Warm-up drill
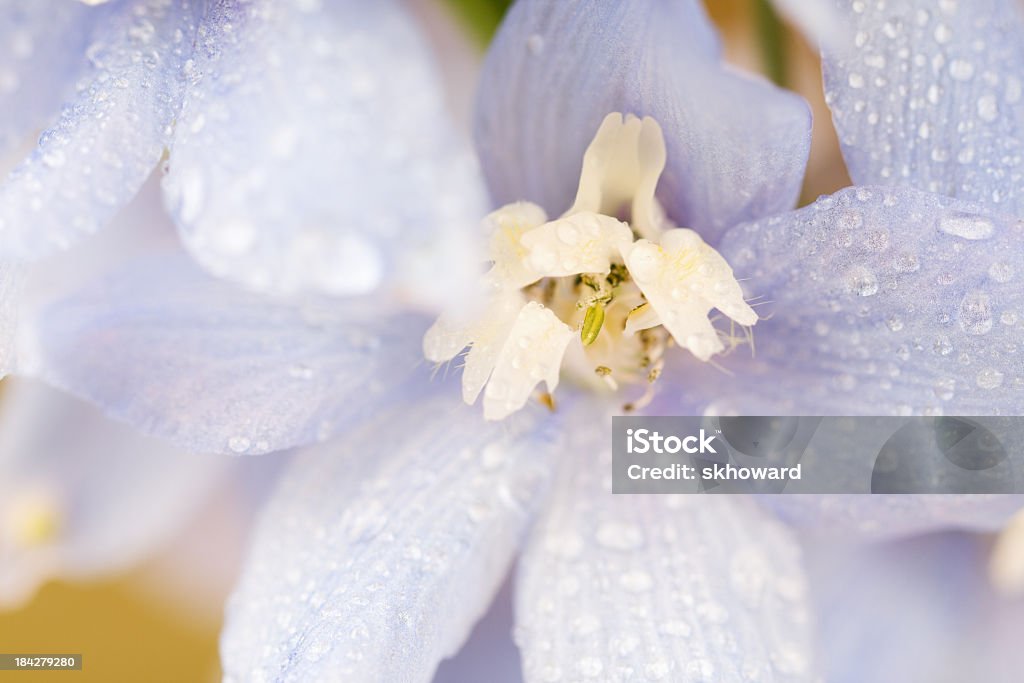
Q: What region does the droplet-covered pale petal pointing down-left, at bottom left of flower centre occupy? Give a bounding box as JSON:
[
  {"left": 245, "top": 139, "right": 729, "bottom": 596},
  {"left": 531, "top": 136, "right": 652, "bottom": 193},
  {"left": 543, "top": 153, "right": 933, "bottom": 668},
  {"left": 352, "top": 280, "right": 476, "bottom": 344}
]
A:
[{"left": 221, "top": 387, "right": 555, "bottom": 681}]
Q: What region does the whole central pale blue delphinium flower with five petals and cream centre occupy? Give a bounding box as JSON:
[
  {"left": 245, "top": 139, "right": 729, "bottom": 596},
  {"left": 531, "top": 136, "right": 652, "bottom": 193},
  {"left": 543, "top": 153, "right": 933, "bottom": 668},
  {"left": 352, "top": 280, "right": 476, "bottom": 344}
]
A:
[{"left": 6, "top": 2, "right": 1020, "bottom": 680}]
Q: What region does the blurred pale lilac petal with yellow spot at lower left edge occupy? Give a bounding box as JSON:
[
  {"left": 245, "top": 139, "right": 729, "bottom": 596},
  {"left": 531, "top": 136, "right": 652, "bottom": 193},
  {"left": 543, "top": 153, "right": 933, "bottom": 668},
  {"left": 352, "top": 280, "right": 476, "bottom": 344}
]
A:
[{"left": 0, "top": 380, "right": 227, "bottom": 606}]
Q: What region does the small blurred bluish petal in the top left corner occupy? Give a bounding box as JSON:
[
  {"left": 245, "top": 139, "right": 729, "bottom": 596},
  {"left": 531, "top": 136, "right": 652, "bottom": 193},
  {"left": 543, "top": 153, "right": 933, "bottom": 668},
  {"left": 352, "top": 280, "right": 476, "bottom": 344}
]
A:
[{"left": 0, "top": 0, "right": 93, "bottom": 160}]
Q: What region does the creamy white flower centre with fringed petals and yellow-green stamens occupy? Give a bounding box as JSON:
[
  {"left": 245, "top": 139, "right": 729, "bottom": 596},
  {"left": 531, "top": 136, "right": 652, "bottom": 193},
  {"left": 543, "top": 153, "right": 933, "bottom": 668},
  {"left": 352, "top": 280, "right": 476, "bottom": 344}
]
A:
[{"left": 423, "top": 114, "right": 758, "bottom": 420}]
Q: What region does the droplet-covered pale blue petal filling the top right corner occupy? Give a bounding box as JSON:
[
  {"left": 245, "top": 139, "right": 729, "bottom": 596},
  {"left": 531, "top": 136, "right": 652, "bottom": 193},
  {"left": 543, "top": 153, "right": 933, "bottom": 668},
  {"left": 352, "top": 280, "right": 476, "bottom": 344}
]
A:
[{"left": 824, "top": 0, "right": 1024, "bottom": 216}]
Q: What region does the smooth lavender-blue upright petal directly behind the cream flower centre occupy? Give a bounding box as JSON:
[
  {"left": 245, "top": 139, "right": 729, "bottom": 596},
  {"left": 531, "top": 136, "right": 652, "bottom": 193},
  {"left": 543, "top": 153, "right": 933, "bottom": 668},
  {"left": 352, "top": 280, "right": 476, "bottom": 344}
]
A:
[{"left": 476, "top": 0, "right": 811, "bottom": 243}]
